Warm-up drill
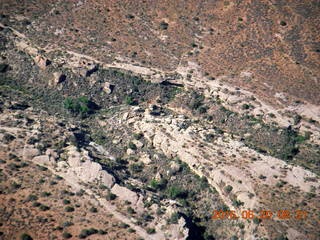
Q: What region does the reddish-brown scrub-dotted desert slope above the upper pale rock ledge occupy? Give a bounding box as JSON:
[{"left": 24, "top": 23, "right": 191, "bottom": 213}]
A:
[{"left": 0, "top": 0, "right": 320, "bottom": 104}]
